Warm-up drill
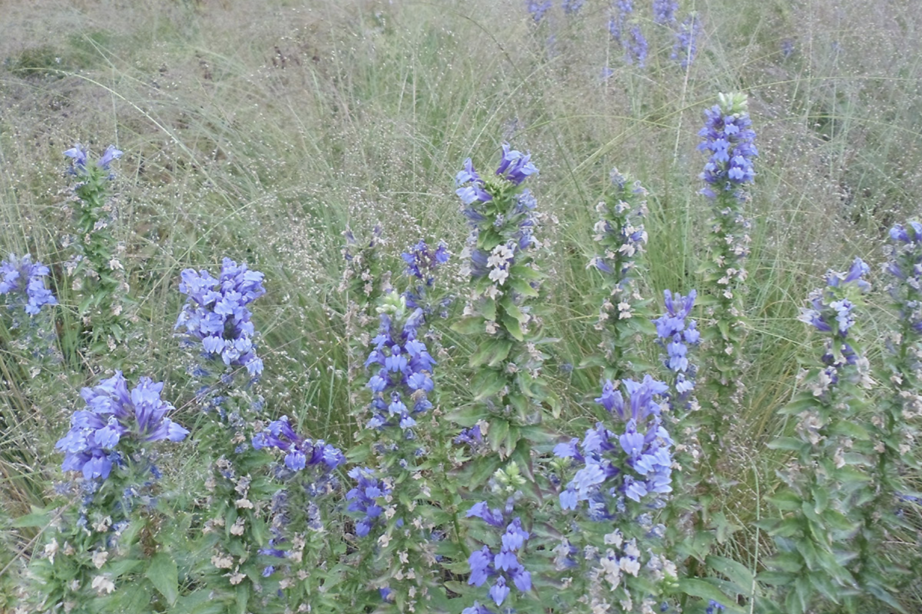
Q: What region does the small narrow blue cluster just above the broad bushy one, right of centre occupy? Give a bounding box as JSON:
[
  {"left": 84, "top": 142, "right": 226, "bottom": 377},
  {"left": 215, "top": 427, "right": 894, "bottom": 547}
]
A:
[{"left": 653, "top": 290, "right": 701, "bottom": 409}]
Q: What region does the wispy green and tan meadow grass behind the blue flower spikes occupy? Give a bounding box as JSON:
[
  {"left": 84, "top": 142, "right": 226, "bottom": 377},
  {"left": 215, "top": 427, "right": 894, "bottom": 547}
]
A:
[{"left": 0, "top": 0, "right": 922, "bottom": 610}]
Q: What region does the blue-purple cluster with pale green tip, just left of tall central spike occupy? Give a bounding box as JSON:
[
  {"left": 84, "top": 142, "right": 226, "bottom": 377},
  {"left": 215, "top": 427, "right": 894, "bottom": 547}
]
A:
[{"left": 365, "top": 309, "right": 435, "bottom": 439}]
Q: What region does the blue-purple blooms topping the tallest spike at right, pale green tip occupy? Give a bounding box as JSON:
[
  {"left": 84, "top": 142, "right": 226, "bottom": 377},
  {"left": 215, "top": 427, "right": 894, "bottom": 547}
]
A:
[{"left": 698, "top": 100, "right": 759, "bottom": 200}]
